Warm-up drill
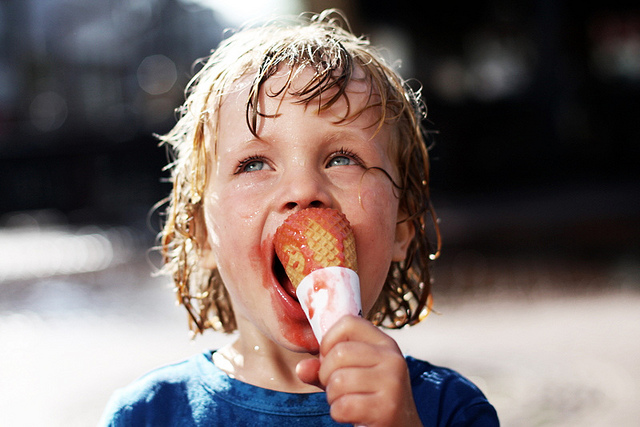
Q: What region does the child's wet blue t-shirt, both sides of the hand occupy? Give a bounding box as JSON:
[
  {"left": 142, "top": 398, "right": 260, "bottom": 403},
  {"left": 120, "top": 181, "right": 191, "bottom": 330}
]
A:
[{"left": 99, "top": 351, "right": 499, "bottom": 427}]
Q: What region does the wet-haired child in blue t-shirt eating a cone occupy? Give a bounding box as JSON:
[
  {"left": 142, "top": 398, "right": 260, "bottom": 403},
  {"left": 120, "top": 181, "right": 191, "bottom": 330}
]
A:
[{"left": 102, "top": 11, "right": 498, "bottom": 426}]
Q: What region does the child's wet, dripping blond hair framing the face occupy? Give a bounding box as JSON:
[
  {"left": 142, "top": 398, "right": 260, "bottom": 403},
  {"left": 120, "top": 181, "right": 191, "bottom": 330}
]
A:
[{"left": 159, "top": 10, "right": 440, "bottom": 333}]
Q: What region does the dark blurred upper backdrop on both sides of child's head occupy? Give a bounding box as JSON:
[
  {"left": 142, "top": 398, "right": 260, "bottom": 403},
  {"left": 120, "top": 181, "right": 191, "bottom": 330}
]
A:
[{"left": 0, "top": 0, "right": 640, "bottom": 270}]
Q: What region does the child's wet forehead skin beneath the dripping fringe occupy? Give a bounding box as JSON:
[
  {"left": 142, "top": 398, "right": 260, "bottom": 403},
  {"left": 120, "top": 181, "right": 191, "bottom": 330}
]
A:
[{"left": 207, "top": 68, "right": 396, "bottom": 166}]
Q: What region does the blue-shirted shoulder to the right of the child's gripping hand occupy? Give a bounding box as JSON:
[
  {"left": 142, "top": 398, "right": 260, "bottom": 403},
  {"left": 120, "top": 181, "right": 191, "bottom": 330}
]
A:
[{"left": 405, "top": 356, "right": 499, "bottom": 427}]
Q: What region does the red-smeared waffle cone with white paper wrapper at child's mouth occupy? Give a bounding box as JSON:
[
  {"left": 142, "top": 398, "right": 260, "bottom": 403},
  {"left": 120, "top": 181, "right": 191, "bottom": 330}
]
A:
[{"left": 274, "top": 208, "right": 362, "bottom": 342}]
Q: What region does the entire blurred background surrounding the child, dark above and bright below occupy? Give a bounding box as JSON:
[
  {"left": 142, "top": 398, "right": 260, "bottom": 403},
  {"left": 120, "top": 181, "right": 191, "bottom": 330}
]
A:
[{"left": 0, "top": 0, "right": 640, "bottom": 426}]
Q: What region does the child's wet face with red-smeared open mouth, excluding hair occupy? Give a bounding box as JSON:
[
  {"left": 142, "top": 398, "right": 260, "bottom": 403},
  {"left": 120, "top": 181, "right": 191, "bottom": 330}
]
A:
[{"left": 203, "top": 67, "right": 413, "bottom": 352}]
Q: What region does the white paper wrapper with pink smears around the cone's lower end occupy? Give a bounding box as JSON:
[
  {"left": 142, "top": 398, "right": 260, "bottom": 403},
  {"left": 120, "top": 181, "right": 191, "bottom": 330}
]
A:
[{"left": 296, "top": 267, "right": 362, "bottom": 342}]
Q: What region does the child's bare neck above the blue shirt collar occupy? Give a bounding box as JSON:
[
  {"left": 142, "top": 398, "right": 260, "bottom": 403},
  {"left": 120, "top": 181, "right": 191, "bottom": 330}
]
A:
[{"left": 213, "top": 337, "right": 320, "bottom": 393}]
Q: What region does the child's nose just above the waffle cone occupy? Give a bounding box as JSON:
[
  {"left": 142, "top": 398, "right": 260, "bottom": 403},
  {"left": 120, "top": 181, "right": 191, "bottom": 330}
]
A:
[{"left": 281, "top": 169, "right": 332, "bottom": 211}]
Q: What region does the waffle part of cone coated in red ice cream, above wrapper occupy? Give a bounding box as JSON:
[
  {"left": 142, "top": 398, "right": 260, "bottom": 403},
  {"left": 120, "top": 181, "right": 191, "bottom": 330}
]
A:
[{"left": 274, "top": 208, "right": 358, "bottom": 288}]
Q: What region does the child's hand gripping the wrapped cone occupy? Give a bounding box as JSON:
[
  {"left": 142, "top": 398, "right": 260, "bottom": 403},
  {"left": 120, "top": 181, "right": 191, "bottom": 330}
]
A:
[{"left": 297, "top": 316, "right": 422, "bottom": 427}]
